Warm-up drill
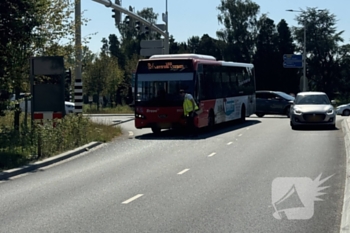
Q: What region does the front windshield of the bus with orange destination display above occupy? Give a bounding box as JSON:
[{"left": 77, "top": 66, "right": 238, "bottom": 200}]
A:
[{"left": 135, "top": 60, "right": 194, "bottom": 106}]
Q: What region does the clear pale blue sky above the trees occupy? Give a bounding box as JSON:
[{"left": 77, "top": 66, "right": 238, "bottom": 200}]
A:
[{"left": 81, "top": 0, "right": 350, "bottom": 53}]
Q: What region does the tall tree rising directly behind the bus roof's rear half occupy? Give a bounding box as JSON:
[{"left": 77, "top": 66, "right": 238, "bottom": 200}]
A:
[{"left": 216, "top": 0, "right": 259, "bottom": 62}]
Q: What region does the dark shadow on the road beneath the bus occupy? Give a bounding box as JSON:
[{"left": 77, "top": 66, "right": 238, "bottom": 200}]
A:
[{"left": 135, "top": 120, "right": 260, "bottom": 140}]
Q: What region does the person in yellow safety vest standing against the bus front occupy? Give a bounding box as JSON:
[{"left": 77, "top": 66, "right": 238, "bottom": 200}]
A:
[{"left": 180, "top": 89, "right": 199, "bottom": 136}]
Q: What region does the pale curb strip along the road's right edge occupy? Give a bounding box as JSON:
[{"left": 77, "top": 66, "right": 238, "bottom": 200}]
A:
[{"left": 340, "top": 118, "right": 350, "bottom": 233}]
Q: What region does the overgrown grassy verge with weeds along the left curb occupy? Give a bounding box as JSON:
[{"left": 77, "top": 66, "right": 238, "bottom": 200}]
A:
[{"left": 0, "top": 112, "right": 122, "bottom": 171}]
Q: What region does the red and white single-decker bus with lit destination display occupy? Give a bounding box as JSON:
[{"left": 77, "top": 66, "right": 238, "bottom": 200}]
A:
[{"left": 135, "top": 54, "right": 255, "bottom": 133}]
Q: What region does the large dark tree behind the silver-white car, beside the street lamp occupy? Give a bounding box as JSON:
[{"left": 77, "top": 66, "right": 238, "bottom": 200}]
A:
[{"left": 294, "top": 8, "right": 344, "bottom": 98}]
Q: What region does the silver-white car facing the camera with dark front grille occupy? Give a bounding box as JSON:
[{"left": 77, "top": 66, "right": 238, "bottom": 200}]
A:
[{"left": 290, "top": 92, "right": 336, "bottom": 129}]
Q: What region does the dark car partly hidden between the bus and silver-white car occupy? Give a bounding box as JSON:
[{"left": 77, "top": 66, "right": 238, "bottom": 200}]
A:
[{"left": 255, "top": 91, "right": 294, "bottom": 117}]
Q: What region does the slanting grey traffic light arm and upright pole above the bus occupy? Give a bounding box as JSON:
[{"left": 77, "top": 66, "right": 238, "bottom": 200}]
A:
[{"left": 92, "top": 0, "right": 169, "bottom": 54}]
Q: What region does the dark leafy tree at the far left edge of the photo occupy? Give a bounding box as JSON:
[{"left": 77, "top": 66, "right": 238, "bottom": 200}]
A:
[{"left": 0, "top": 0, "right": 44, "bottom": 124}]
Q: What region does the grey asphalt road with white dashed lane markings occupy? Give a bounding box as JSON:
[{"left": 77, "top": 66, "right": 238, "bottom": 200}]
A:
[{"left": 0, "top": 117, "right": 345, "bottom": 233}]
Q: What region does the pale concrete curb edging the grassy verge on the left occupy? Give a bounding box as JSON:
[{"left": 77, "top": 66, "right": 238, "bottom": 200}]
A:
[{"left": 0, "top": 142, "right": 102, "bottom": 180}]
